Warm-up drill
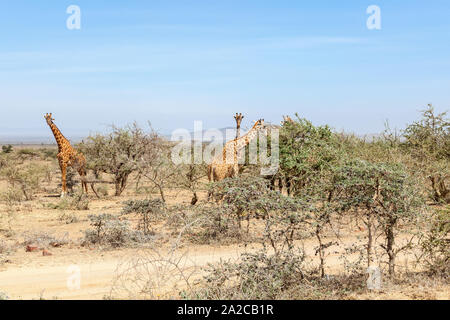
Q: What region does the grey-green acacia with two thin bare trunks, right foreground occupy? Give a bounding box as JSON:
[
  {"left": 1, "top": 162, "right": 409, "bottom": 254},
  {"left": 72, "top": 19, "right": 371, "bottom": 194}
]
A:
[{"left": 333, "top": 160, "right": 423, "bottom": 275}]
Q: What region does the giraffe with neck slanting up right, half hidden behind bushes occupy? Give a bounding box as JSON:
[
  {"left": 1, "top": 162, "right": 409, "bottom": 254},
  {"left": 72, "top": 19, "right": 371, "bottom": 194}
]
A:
[{"left": 208, "top": 119, "right": 265, "bottom": 182}]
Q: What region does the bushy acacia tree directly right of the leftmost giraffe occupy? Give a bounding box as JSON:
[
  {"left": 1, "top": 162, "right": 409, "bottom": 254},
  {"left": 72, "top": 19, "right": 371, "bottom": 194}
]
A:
[{"left": 79, "top": 123, "right": 160, "bottom": 196}]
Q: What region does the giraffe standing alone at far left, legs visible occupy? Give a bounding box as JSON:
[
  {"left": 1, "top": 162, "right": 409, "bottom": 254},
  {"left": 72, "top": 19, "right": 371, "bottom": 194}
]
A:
[{"left": 44, "top": 113, "right": 88, "bottom": 197}]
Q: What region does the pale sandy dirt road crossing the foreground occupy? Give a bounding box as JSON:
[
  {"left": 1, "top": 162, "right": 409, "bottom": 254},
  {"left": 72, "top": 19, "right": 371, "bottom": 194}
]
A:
[{"left": 0, "top": 247, "right": 248, "bottom": 299}]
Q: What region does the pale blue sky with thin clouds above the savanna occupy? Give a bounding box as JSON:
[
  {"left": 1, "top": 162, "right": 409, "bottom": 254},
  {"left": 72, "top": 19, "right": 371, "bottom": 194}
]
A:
[{"left": 0, "top": 0, "right": 450, "bottom": 136}]
